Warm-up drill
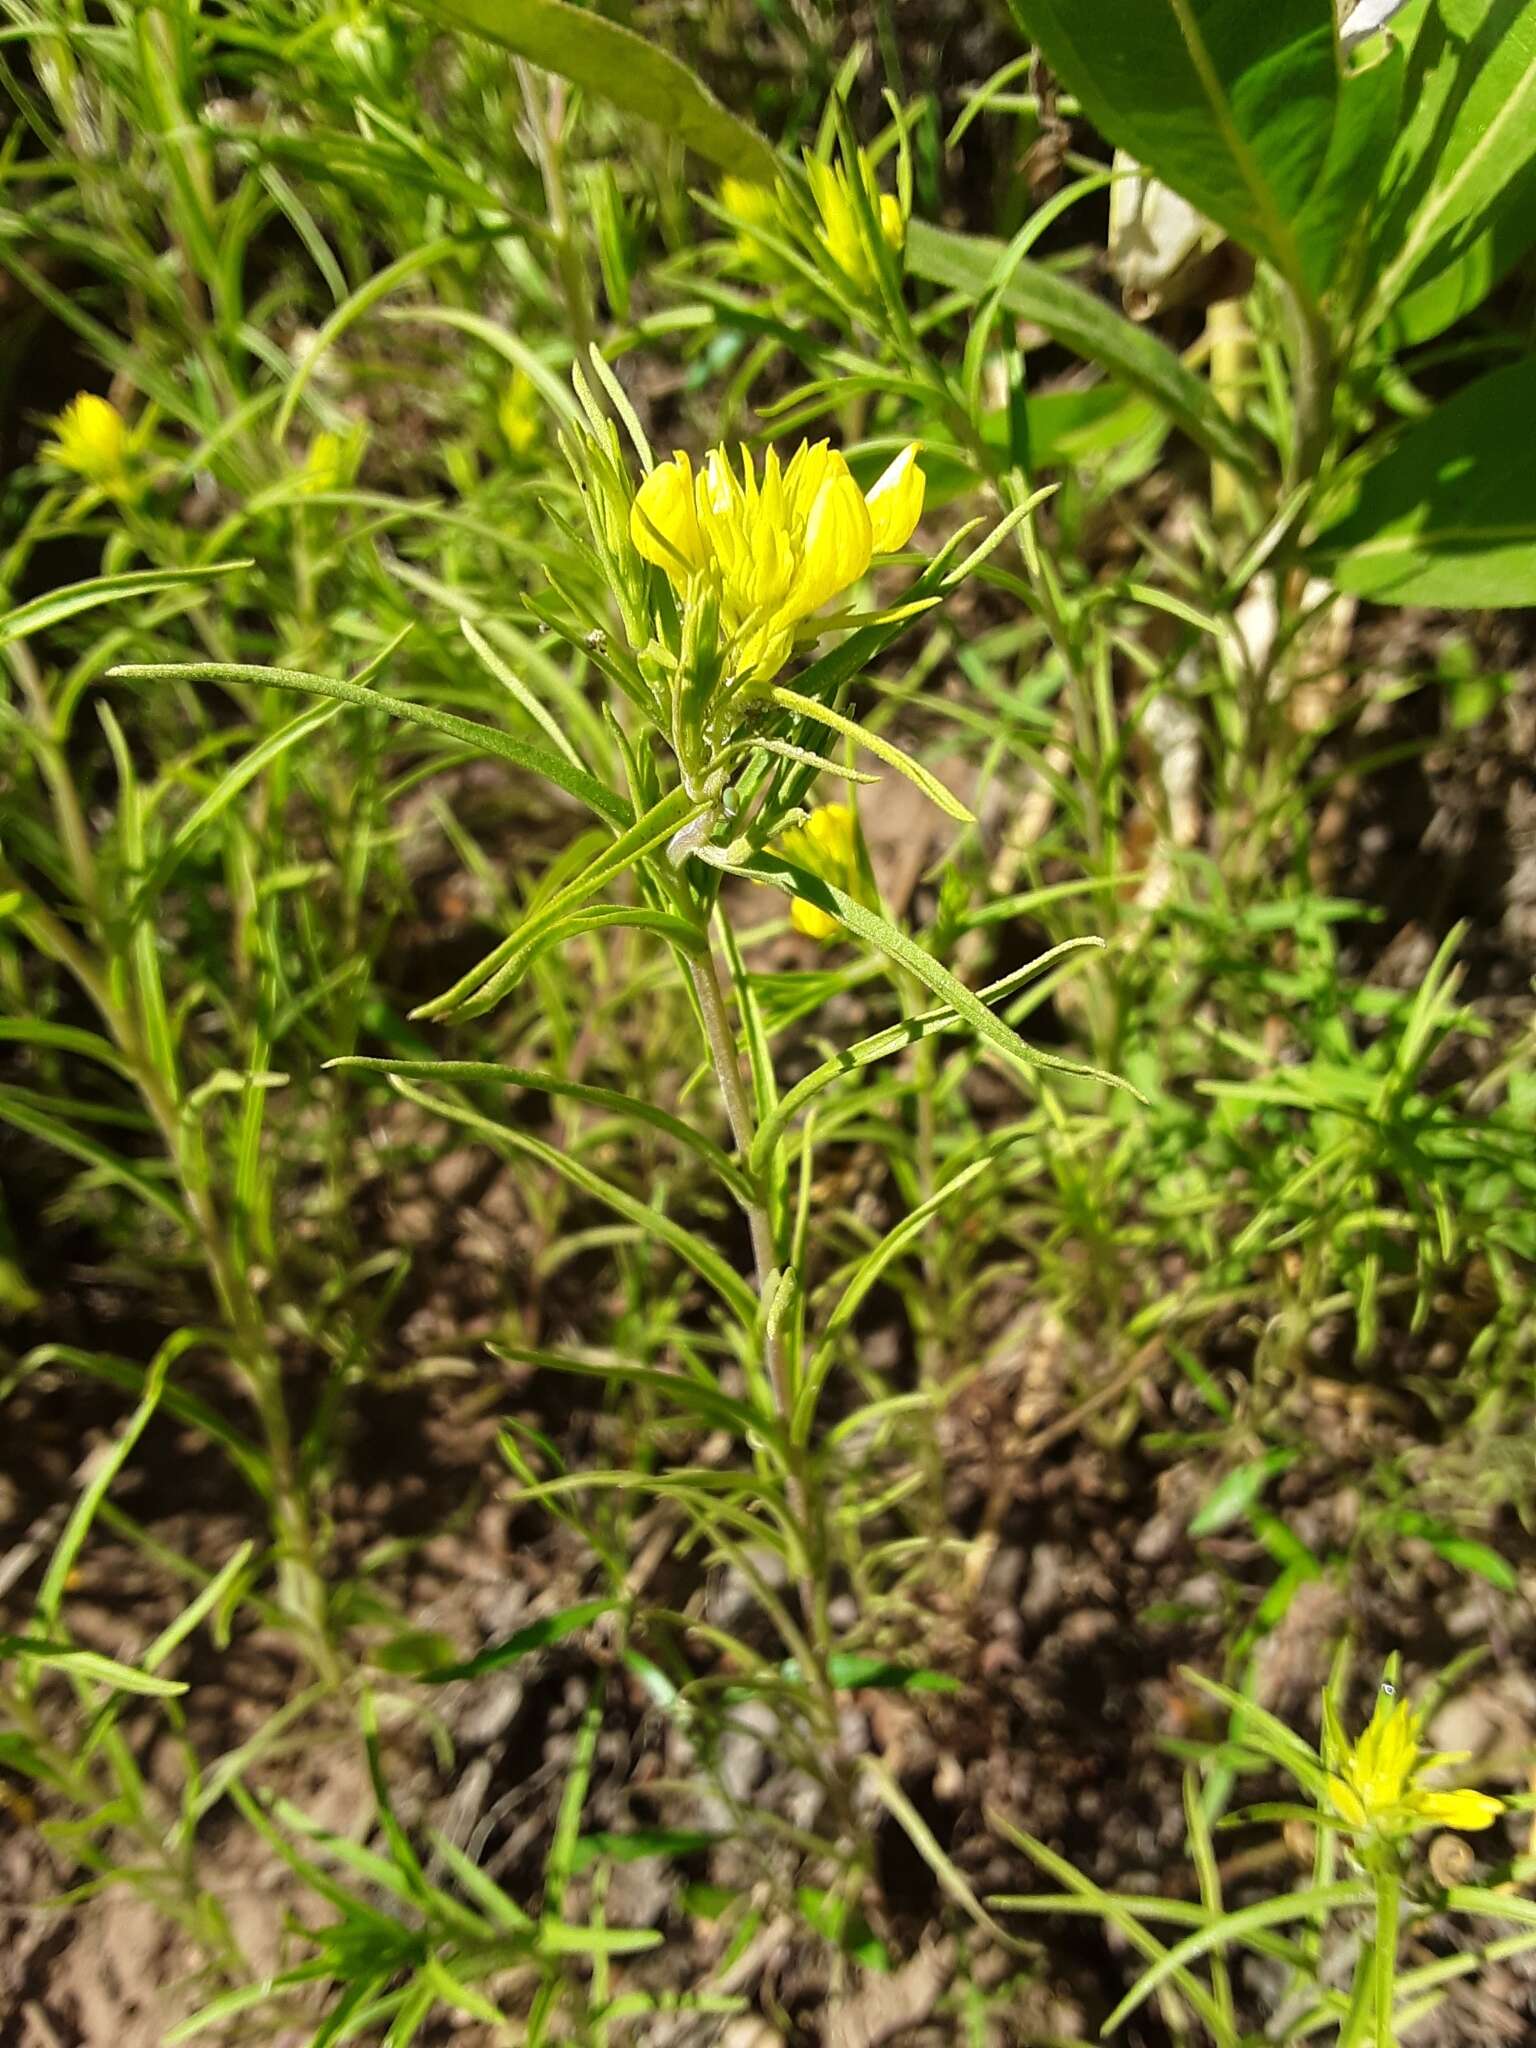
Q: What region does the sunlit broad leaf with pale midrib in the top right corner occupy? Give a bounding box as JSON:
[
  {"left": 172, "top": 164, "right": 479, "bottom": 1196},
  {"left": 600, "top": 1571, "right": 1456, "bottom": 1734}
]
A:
[{"left": 1372, "top": 0, "right": 1536, "bottom": 317}]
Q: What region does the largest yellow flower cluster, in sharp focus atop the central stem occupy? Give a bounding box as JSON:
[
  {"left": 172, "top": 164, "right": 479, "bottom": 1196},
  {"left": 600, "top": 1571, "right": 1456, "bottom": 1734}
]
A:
[{"left": 629, "top": 440, "right": 924, "bottom": 682}]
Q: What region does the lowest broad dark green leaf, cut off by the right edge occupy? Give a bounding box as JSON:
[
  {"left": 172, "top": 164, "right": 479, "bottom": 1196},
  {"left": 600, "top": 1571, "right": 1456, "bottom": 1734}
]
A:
[{"left": 1313, "top": 358, "right": 1536, "bottom": 606}]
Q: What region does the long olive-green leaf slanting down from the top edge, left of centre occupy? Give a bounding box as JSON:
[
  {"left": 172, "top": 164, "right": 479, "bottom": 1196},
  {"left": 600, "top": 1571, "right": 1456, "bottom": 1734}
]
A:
[{"left": 408, "top": 0, "right": 778, "bottom": 182}]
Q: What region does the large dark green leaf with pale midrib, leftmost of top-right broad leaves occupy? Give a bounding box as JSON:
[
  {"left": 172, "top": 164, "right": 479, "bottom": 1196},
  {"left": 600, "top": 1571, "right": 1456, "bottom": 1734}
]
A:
[{"left": 1012, "top": 0, "right": 1364, "bottom": 283}]
